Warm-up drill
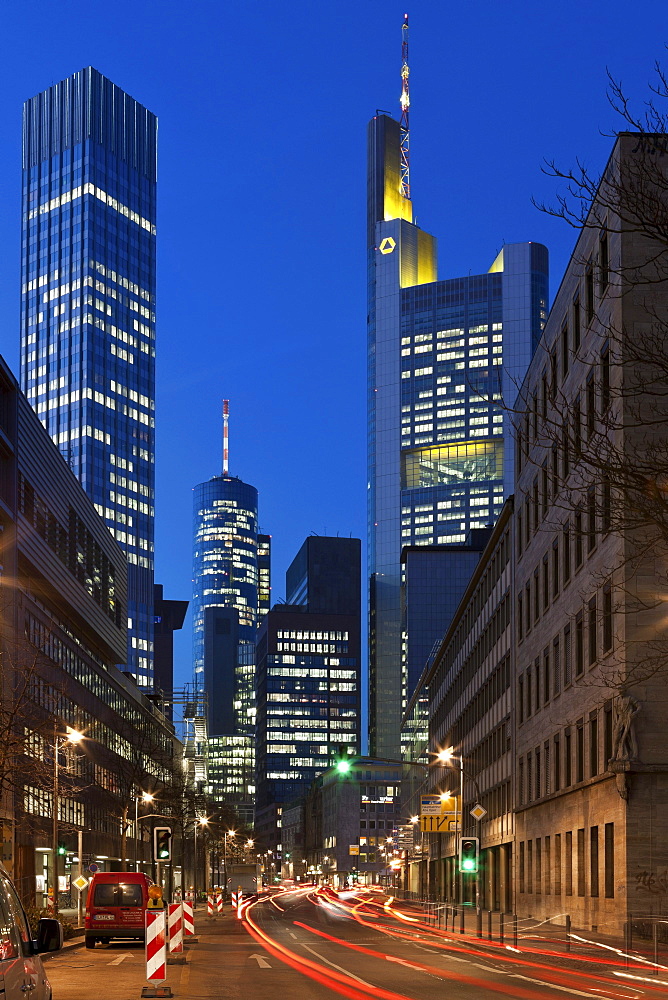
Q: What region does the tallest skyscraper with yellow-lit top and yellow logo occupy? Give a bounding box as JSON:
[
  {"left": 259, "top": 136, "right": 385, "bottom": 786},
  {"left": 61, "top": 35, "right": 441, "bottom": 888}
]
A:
[{"left": 367, "top": 45, "right": 548, "bottom": 758}]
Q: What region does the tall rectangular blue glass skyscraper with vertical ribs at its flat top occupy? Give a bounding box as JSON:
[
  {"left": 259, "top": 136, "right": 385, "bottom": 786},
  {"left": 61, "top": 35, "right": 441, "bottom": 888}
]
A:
[{"left": 21, "top": 67, "right": 157, "bottom": 687}]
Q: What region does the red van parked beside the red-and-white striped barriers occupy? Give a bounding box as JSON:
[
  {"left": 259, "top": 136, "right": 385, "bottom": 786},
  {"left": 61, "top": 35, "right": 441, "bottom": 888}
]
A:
[{"left": 85, "top": 872, "right": 153, "bottom": 948}]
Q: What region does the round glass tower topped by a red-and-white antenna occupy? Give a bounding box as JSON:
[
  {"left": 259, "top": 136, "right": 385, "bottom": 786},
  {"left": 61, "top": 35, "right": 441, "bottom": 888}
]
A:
[{"left": 193, "top": 475, "right": 258, "bottom": 736}]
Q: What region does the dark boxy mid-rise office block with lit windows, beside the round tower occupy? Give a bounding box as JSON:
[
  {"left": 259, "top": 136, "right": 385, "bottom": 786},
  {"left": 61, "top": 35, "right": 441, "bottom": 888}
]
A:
[{"left": 256, "top": 537, "right": 361, "bottom": 846}]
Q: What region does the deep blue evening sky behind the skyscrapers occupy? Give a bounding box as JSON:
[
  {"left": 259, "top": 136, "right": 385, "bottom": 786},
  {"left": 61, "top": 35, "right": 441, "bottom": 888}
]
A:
[{"left": 0, "top": 0, "right": 668, "bottom": 704}]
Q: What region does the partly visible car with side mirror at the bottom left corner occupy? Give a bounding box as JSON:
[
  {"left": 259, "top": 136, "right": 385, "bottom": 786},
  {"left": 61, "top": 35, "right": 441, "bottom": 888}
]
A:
[{"left": 0, "top": 868, "right": 63, "bottom": 1000}]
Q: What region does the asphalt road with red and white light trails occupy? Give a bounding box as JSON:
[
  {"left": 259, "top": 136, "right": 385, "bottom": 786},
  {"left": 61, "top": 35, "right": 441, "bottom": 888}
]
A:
[{"left": 47, "top": 890, "right": 668, "bottom": 1000}]
